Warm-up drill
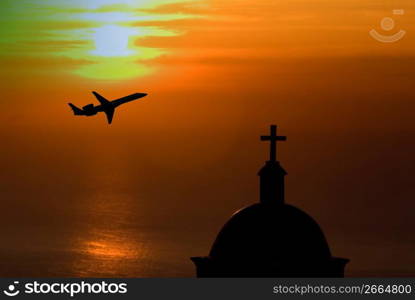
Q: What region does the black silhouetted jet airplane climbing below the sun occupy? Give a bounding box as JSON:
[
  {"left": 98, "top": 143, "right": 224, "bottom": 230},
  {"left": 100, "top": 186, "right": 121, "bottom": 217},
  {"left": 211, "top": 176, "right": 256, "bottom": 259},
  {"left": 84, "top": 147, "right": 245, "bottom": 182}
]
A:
[{"left": 68, "top": 92, "right": 147, "bottom": 124}]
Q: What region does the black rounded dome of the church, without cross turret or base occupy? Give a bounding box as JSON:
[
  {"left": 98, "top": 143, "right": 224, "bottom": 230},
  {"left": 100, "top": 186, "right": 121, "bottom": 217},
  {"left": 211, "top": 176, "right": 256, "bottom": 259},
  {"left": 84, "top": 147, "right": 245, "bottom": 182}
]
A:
[{"left": 209, "top": 203, "right": 331, "bottom": 264}]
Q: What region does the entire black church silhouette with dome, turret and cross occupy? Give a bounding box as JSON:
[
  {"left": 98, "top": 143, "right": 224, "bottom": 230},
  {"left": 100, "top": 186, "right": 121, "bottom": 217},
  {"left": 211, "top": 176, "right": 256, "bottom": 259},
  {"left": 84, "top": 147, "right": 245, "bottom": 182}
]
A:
[{"left": 191, "top": 125, "right": 349, "bottom": 277}]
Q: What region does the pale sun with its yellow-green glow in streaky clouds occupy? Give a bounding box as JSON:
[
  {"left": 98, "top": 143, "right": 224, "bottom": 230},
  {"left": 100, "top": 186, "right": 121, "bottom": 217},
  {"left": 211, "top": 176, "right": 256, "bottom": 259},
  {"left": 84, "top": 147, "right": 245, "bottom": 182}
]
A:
[{"left": 0, "top": 0, "right": 202, "bottom": 80}]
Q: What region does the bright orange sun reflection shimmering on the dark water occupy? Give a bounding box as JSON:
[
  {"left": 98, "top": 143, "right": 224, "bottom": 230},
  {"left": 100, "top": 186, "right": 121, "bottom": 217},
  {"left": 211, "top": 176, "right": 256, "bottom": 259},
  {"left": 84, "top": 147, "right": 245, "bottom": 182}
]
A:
[{"left": 72, "top": 196, "right": 149, "bottom": 277}]
